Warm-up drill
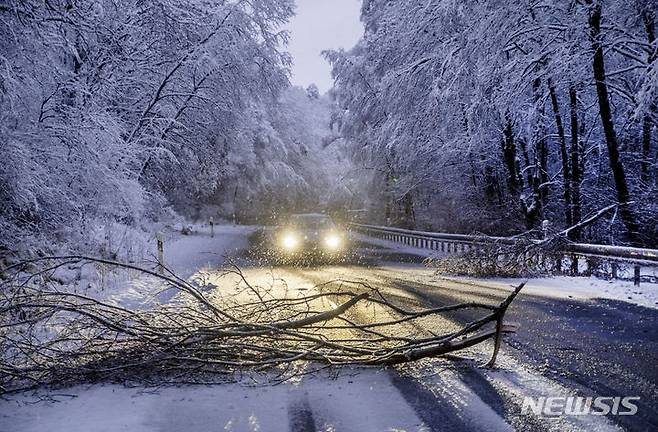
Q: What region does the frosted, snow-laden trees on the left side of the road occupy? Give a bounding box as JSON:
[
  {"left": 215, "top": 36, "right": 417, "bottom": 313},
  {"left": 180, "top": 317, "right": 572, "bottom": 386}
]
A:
[{"left": 0, "top": 0, "right": 356, "bottom": 256}]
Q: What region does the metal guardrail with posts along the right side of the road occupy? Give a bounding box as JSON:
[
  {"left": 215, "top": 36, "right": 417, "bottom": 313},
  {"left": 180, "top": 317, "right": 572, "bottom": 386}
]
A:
[{"left": 349, "top": 223, "right": 658, "bottom": 285}]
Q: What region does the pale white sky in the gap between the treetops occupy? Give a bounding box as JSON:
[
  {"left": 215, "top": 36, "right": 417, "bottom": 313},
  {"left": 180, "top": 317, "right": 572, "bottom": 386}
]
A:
[{"left": 288, "top": 0, "right": 363, "bottom": 93}]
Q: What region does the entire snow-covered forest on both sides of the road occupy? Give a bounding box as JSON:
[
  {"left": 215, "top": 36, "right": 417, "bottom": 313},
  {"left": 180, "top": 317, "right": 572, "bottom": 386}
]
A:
[{"left": 0, "top": 0, "right": 658, "bottom": 256}]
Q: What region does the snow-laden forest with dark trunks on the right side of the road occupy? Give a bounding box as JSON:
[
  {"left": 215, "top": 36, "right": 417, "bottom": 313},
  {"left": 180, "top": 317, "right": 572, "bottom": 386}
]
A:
[{"left": 326, "top": 0, "right": 658, "bottom": 246}]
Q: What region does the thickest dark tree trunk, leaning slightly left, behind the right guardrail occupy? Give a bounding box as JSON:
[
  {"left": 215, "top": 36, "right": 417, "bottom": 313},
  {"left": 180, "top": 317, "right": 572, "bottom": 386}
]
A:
[{"left": 589, "top": 0, "right": 641, "bottom": 245}]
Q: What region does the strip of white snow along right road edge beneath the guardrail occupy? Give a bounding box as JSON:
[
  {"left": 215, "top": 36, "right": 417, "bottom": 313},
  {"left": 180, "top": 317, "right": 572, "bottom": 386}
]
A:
[{"left": 351, "top": 233, "right": 658, "bottom": 309}]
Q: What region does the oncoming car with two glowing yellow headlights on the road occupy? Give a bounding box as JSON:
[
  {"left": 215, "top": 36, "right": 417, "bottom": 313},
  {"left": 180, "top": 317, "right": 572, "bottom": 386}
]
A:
[{"left": 273, "top": 213, "right": 348, "bottom": 261}]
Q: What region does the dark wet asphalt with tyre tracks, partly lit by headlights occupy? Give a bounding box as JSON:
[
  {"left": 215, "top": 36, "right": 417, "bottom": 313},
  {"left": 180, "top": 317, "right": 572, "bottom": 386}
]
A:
[{"left": 224, "top": 233, "right": 658, "bottom": 431}]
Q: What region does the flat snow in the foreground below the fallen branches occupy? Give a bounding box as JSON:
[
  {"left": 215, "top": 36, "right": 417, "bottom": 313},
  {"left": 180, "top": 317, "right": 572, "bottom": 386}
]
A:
[{"left": 0, "top": 370, "right": 429, "bottom": 432}]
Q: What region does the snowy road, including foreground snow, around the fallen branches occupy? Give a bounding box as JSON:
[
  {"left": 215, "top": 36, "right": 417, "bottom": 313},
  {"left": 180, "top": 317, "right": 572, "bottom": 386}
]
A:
[{"left": 0, "top": 230, "right": 658, "bottom": 432}]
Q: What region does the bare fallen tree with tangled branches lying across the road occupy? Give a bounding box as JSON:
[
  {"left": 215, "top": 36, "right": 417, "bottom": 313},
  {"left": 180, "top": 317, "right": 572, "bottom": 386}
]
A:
[{"left": 0, "top": 256, "right": 523, "bottom": 392}]
